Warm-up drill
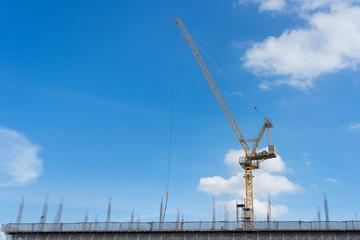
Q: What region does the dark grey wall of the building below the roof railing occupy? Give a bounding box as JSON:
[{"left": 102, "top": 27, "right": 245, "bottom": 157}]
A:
[{"left": 7, "top": 231, "right": 360, "bottom": 240}]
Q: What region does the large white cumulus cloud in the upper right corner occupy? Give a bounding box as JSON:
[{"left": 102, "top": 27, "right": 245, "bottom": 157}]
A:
[{"left": 242, "top": 0, "right": 360, "bottom": 90}]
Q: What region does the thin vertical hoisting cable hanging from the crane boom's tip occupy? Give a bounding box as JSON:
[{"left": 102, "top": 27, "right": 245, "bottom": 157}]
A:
[{"left": 162, "top": 23, "right": 178, "bottom": 222}]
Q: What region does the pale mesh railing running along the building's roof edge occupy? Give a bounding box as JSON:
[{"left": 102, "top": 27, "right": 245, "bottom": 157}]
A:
[{"left": 1, "top": 221, "right": 360, "bottom": 234}]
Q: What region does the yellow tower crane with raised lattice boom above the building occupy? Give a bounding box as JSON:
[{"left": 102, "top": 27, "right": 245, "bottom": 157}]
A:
[{"left": 173, "top": 18, "right": 276, "bottom": 222}]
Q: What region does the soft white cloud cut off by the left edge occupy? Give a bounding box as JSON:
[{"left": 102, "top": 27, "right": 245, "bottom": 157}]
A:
[{"left": 0, "top": 127, "right": 42, "bottom": 187}]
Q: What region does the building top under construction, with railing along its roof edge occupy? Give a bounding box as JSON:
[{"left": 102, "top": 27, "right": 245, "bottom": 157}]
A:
[{"left": 2, "top": 221, "right": 360, "bottom": 240}]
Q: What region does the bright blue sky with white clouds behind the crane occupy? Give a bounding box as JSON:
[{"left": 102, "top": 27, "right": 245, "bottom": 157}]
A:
[{"left": 0, "top": 0, "right": 360, "bottom": 229}]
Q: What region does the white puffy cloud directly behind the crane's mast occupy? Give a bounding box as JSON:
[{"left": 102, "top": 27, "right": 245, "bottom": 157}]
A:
[{"left": 198, "top": 149, "right": 300, "bottom": 218}]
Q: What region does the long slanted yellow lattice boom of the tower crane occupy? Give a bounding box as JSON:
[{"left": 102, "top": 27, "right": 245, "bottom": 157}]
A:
[{"left": 174, "top": 18, "right": 250, "bottom": 156}]
